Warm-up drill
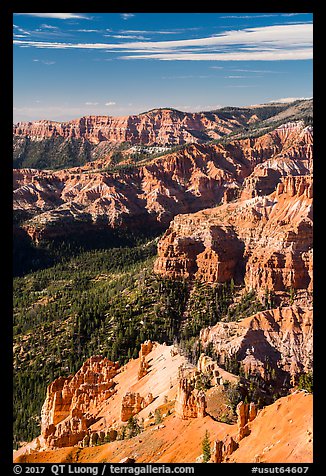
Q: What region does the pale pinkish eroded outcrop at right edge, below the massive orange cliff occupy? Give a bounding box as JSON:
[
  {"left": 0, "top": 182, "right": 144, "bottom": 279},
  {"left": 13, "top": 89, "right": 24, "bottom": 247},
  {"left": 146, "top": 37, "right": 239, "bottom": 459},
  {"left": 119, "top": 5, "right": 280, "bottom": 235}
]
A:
[{"left": 200, "top": 306, "right": 313, "bottom": 380}]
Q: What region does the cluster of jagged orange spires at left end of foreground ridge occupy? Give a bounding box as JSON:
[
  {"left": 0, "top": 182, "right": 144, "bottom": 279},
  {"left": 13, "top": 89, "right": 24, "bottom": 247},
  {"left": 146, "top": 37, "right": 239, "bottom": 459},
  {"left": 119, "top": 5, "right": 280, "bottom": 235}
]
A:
[{"left": 41, "top": 356, "right": 119, "bottom": 447}]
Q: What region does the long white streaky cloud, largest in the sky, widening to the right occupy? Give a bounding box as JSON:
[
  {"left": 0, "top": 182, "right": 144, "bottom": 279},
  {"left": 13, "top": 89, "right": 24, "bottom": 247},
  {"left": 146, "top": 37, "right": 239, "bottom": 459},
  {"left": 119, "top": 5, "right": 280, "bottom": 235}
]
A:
[{"left": 14, "top": 23, "right": 313, "bottom": 61}]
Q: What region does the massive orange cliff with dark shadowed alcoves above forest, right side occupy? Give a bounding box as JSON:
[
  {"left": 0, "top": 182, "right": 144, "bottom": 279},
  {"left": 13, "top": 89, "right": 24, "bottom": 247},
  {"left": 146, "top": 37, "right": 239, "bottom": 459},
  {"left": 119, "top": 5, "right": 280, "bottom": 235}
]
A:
[{"left": 154, "top": 175, "right": 313, "bottom": 294}]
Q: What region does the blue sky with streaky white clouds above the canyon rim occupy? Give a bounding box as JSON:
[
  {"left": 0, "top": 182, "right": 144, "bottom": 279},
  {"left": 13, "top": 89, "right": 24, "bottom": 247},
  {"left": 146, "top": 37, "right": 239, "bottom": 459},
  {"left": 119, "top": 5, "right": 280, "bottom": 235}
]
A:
[{"left": 13, "top": 12, "right": 313, "bottom": 122}]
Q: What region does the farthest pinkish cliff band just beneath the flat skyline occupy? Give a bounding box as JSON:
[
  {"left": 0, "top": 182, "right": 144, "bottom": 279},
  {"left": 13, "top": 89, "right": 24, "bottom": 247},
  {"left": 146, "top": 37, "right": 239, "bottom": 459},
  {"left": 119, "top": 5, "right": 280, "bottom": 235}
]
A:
[{"left": 13, "top": 109, "right": 247, "bottom": 145}]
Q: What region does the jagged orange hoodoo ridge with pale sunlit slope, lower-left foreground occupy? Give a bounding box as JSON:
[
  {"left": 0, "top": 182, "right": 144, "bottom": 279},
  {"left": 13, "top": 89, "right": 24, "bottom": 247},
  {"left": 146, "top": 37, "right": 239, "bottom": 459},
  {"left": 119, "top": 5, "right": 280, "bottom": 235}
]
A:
[{"left": 18, "top": 341, "right": 191, "bottom": 454}]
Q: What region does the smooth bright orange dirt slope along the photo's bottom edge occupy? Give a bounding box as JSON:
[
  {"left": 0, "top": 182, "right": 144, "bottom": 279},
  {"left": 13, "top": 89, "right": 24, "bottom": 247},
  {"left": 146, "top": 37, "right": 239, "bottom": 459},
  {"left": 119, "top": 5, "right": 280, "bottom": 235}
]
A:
[{"left": 14, "top": 392, "right": 313, "bottom": 462}]
